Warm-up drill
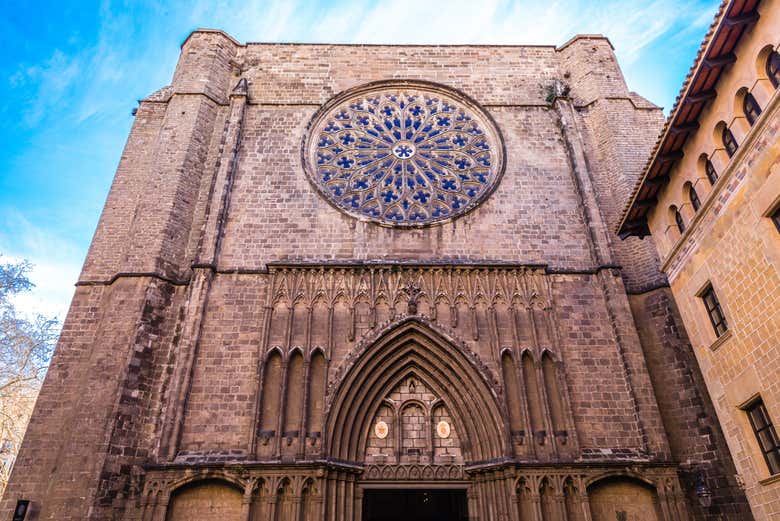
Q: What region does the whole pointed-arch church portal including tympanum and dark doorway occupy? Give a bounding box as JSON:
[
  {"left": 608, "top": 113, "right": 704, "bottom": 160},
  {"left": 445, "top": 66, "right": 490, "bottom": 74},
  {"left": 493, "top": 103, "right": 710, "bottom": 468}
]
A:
[{"left": 325, "top": 319, "right": 510, "bottom": 521}]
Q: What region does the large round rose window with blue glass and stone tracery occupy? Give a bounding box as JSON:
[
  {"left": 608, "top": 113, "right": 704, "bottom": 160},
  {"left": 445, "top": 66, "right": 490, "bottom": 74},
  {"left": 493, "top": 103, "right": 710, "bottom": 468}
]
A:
[{"left": 305, "top": 83, "right": 503, "bottom": 226}]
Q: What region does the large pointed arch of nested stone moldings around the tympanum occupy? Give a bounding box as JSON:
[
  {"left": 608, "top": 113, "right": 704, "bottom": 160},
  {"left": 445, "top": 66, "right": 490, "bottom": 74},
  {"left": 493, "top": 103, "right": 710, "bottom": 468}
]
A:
[{"left": 325, "top": 319, "right": 508, "bottom": 462}]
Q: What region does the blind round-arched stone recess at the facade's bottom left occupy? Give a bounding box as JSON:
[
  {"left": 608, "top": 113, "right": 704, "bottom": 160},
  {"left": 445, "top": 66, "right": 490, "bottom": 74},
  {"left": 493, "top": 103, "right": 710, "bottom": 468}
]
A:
[{"left": 165, "top": 479, "right": 243, "bottom": 521}]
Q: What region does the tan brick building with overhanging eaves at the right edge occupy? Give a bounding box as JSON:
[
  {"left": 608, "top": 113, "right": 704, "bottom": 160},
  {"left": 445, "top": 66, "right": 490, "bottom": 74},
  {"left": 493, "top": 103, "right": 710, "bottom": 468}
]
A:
[{"left": 620, "top": 0, "right": 780, "bottom": 520}]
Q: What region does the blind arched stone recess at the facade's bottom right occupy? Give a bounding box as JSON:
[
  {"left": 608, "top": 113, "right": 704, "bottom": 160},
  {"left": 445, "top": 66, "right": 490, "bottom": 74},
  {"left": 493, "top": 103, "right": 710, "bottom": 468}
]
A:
[{"left": 588, "top": 476, "right": 664, "bottom": 521}]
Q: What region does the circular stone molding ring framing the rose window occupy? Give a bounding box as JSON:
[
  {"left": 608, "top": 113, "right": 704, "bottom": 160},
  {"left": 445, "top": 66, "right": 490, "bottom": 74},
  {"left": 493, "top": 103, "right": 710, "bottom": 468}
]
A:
[{"left": 300, "top": 79, "right": 506, "bottom": 229}]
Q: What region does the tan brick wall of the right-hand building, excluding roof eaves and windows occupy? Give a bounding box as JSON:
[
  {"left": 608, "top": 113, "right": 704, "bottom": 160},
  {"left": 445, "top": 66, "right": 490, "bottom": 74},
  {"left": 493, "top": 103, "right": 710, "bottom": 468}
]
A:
[{"left": 648, "top": 1, "right": 780, "bottom": 519}]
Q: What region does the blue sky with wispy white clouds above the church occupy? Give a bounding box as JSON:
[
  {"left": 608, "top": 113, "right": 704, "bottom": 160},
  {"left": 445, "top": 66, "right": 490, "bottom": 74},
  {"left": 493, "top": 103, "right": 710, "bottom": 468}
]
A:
[{"left": 0, "top": 0, "right": 719, "bottom": 319}]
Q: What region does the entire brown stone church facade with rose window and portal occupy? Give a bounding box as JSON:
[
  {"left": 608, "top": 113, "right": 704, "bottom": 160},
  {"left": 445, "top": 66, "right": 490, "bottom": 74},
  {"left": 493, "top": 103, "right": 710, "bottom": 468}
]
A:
[{"left": 0, "top": 25, "right": 752, "bottom": 521}]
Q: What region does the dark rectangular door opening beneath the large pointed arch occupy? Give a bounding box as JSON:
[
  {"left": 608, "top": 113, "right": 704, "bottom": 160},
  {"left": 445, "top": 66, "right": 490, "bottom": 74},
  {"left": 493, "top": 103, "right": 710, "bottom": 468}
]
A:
[{"left": 363, "top": 489, "right": 468, "bottom": 521}]
